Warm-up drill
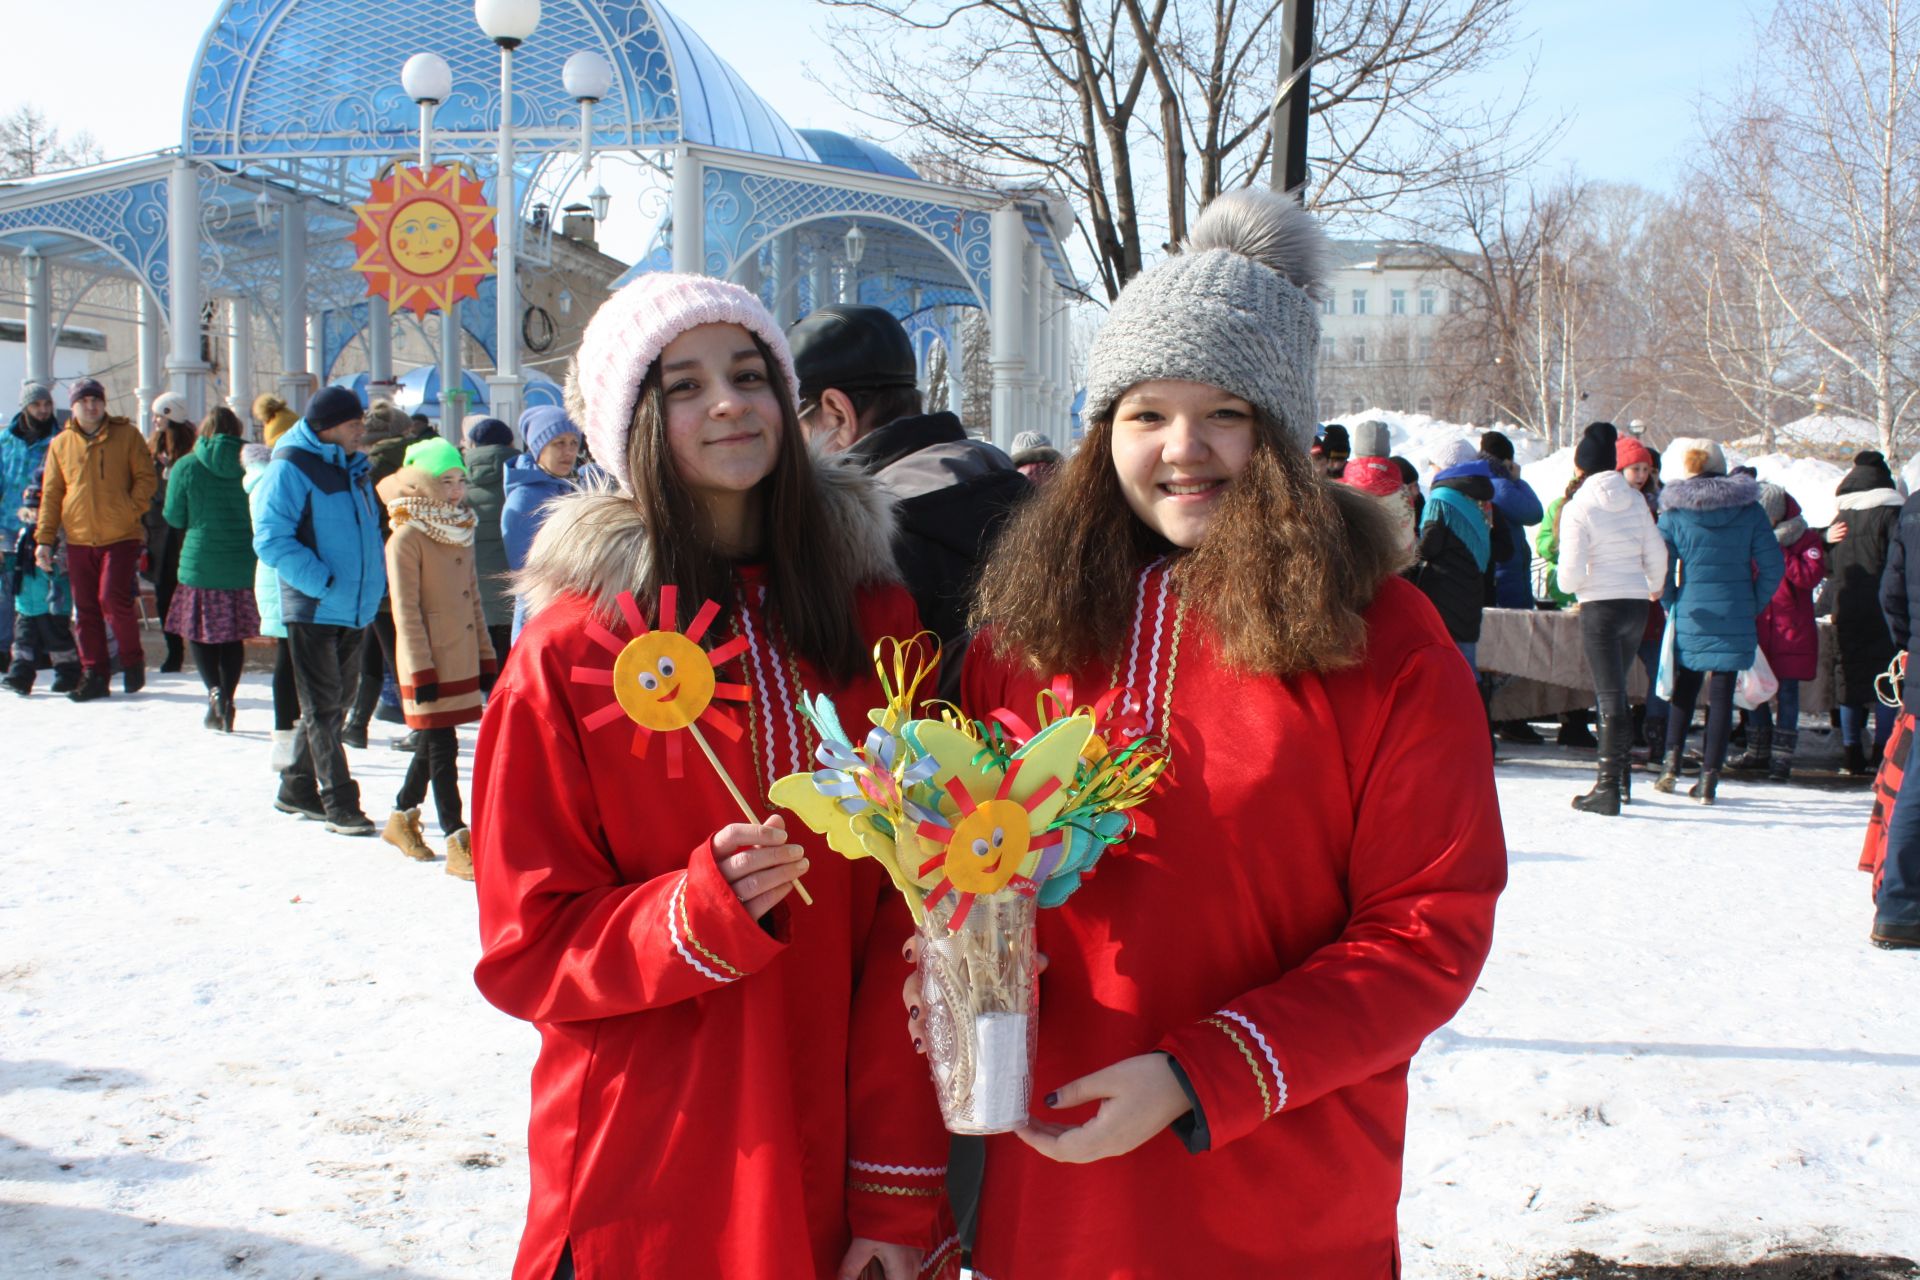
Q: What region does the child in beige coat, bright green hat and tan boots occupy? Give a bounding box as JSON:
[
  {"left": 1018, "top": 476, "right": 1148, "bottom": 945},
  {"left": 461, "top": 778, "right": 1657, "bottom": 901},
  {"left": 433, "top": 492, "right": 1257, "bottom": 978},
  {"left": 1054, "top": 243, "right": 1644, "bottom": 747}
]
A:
[{"left": 378, "top": 436, "right": 495, "bottom": 881}]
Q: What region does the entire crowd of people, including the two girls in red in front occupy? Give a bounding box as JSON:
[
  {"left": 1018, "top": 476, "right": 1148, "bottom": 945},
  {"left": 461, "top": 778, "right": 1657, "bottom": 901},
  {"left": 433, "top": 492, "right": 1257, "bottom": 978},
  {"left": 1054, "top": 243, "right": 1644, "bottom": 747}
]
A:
[{"left": 0, "top": 190, "right": 1920, "bottom": 1280}]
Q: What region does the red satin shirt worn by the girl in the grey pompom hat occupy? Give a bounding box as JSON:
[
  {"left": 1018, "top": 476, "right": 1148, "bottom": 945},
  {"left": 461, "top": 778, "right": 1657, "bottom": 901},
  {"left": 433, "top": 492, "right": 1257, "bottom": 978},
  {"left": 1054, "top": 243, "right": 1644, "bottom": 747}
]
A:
[{"left": 964, "top": 566, "right": 1507, "bottom": 1280}]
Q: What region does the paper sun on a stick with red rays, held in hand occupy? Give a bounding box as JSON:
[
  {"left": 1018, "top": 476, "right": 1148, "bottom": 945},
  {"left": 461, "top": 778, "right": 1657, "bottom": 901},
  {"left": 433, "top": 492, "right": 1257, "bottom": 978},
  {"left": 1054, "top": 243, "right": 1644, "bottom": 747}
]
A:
[{"left": 572, "top": 585, "right": 814, "bottom": 906}]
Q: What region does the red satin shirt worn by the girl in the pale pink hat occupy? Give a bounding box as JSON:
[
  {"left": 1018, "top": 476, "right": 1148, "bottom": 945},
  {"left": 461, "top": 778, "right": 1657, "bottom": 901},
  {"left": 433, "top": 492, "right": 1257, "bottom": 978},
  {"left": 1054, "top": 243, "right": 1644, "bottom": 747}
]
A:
[{"left": 472, "top": 570, "right": 956, "bottom": 1280}]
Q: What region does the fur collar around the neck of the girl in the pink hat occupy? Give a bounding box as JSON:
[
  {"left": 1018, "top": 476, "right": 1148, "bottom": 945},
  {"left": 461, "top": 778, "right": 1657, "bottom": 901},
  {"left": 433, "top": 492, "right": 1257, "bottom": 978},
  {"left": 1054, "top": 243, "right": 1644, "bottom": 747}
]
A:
[{"left": 513, "top": 453, "right": 900, "bottom": 618}]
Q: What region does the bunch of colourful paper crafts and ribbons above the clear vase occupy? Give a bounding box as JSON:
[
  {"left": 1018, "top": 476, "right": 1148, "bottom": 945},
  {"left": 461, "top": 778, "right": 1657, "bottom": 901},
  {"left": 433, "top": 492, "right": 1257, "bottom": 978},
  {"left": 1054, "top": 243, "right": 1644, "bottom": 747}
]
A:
[{"left": 770, "top": 633, "right": 1167, "bottom": 931}]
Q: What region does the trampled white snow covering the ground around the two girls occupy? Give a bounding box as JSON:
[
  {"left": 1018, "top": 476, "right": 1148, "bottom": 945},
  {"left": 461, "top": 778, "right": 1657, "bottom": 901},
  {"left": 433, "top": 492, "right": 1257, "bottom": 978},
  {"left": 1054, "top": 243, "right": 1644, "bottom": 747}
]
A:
[{"left": 0, "top": 676, "right": 1920, "bottom": 1280}]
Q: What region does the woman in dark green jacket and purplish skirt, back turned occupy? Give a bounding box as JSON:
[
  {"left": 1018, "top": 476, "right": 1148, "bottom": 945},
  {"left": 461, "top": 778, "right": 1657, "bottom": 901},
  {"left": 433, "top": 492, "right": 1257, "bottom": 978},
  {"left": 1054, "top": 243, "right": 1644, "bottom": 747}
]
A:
[{"left": 165, "top": 405, "right": 259, "bottom": 733}]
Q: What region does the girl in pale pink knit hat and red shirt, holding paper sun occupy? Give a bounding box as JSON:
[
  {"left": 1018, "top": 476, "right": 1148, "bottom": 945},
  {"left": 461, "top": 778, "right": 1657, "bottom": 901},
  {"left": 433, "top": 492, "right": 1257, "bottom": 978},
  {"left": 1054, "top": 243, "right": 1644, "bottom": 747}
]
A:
[{"left": 472, "top": 274, "right": 954, "bottom": 1280}]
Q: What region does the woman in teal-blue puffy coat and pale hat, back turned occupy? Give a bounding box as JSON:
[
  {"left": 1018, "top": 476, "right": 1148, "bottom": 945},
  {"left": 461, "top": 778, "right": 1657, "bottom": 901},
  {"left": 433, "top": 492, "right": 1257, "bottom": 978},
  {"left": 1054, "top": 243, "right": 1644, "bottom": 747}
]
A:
[{"left": 1653, "top": 439, "right": 1786, "bottom": 804}]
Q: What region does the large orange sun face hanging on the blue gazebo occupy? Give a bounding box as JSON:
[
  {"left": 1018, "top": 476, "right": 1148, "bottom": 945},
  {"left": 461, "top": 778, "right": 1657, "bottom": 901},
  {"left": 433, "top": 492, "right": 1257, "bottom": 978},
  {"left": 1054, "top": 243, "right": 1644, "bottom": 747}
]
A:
[{"left": 349, "top": 165, "right": 497, "bottom": 315}]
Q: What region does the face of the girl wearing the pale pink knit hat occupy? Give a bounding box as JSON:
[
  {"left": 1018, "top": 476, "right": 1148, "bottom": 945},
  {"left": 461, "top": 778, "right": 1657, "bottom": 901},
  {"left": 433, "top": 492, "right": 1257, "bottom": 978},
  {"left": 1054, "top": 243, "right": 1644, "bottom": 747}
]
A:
[{"left": 660, "top": 324, "right": 780, "bottom": 507}]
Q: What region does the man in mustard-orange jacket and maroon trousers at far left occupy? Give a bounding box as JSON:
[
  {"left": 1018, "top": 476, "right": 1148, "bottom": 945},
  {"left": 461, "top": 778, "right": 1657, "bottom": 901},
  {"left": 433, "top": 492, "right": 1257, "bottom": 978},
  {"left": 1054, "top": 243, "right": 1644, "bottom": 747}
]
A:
[{"left": 35, "top": 378, "right": 159, "bottom": 702}]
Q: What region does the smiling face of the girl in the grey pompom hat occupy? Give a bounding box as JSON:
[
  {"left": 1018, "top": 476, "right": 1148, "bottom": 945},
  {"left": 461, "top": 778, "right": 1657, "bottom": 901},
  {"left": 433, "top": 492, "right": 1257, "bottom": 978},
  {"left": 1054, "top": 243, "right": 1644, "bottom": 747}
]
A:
[{"left": 1114, "top": 380, "right": 1254, "bottom": 549}]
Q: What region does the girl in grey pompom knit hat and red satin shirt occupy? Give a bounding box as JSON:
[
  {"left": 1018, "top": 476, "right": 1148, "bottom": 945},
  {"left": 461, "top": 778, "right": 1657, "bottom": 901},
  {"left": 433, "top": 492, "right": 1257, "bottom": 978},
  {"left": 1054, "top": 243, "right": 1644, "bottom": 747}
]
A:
[{"left": 908, "top": 192, "right": 1505, "bottom": 1280}]
